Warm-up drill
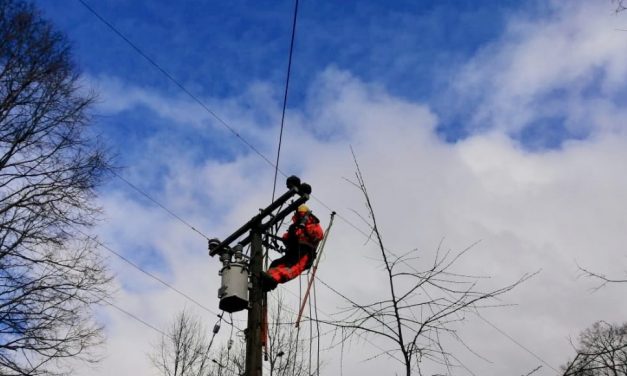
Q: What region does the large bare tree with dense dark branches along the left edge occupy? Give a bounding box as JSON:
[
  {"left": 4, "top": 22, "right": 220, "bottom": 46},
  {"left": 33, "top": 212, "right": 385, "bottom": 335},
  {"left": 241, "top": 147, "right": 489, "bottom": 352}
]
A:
[{"left": 0, "top": 0, "right": 110, "bottom": 375}]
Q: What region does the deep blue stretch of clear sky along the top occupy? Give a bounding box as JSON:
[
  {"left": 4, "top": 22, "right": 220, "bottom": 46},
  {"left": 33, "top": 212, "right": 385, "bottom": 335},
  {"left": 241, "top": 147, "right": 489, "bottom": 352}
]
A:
[{"left": 38, "top": 1, "right": 546, "bottom": 147}]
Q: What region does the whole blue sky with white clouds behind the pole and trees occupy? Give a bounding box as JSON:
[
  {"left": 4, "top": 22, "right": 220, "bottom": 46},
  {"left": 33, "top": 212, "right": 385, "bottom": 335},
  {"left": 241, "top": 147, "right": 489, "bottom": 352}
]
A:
[{"left": 35, "top": 0, "right": 627, "bottom": 376}]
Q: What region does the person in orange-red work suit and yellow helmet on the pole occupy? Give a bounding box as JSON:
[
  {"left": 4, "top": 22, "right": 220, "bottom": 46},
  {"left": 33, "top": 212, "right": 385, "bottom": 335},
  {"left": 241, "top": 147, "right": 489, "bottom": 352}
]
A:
[{"left": 262, "top": 205, "right": 323, "bottom": 291}]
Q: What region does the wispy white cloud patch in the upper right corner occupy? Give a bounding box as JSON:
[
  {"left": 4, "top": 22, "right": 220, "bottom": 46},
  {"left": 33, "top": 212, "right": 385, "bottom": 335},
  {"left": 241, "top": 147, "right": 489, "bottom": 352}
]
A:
[{"left": 453, "top": 1, "right": 627, "bottom": 132}]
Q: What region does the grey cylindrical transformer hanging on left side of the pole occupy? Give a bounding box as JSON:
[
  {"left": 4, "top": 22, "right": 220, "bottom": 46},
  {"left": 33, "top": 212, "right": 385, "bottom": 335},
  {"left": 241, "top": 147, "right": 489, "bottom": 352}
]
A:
[{"left": 218, "top": 245, "right": 248, "bottom": 313}]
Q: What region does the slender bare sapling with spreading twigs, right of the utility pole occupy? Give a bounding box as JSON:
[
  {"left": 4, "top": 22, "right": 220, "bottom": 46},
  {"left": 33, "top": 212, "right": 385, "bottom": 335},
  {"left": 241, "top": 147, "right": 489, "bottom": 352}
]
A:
[{"left": 328, "top": 151, "right": 529, "bottom": 376}]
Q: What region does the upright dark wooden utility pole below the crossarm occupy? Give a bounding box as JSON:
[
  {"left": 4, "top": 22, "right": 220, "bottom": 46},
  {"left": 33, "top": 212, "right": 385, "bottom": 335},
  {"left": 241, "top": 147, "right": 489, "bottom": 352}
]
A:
[{"left": 245, "top": 222, "right": 263, "bottom": 376}]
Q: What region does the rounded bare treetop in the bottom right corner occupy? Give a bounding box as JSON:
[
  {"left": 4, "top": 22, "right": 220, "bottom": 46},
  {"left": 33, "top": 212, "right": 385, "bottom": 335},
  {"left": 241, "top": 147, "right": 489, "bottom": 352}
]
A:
[{"left": 562, "top": 321, "right": 627, "bottom": 376}]
